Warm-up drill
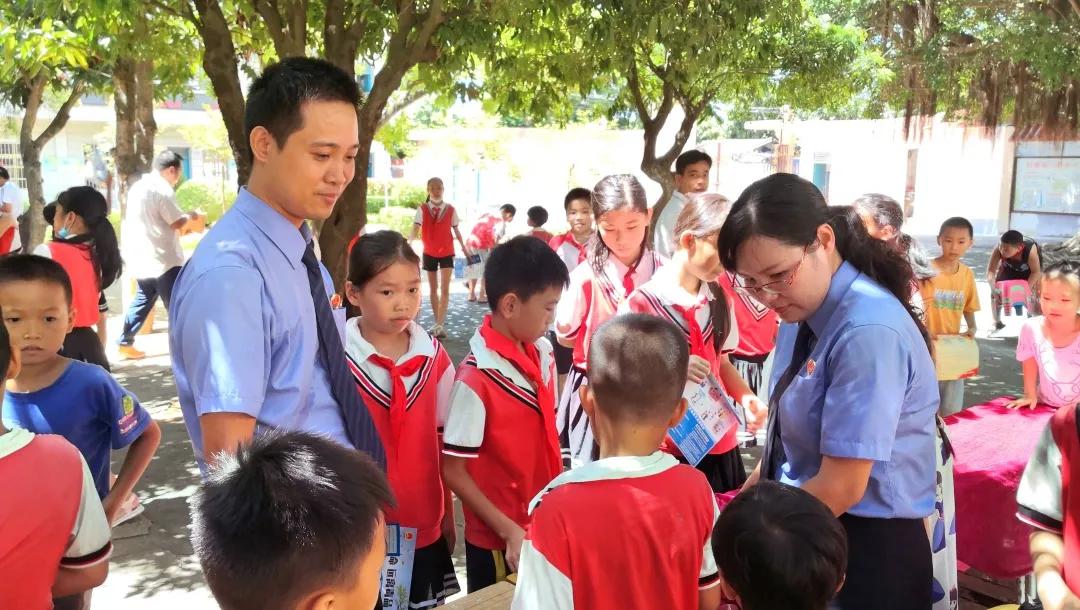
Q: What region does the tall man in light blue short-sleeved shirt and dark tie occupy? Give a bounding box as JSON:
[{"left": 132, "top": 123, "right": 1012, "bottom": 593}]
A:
[{"left": 170, "top": 57, "right": 386, "bottom": 473}]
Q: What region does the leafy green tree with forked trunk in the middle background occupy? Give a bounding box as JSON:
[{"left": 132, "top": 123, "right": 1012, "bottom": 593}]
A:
[{"left": 484, "top": 0, "right": 878, "bottom": 206}]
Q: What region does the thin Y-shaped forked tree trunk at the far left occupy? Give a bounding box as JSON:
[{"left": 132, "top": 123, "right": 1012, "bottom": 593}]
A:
[{"left": 18, "top": 73, "right": 85, "bottom": 247}]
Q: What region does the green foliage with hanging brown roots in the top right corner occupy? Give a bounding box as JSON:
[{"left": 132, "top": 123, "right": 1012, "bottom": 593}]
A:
[{"left": 820, "top": 0, "right": 1080, "bottom": 137}]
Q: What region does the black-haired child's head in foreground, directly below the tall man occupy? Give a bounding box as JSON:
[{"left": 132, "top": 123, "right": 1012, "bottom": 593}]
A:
[{"left": 191, "top": 432, "right": 393, "bottom": 610}]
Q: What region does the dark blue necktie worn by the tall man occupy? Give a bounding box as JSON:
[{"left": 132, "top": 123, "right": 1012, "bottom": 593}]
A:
[{"left": 302, "top": 242, "right": 387, "bottom": 471}]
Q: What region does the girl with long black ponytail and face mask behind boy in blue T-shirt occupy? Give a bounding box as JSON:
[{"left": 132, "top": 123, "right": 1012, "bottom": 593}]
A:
[{"left": 33, "top": 187, "right": 123, "bottom": 370}]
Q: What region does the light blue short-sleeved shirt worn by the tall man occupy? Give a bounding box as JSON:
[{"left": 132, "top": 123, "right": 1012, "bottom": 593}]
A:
[{"left": 168, "top": 189, "right": 351, "bottom": 474}]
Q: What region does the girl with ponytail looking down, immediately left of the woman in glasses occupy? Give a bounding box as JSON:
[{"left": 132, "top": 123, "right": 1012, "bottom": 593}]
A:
[{"left": 619, "top": 193, "right": 766, "bottom": 493}]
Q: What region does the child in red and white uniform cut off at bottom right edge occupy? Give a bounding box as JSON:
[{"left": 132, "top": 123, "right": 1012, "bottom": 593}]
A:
[{"left": 1016, "top": 405, "right": 1080, "bottom": 610}]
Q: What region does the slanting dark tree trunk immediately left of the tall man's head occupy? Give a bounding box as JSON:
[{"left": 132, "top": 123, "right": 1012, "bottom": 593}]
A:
[{"left": 193, "top": 0, "right": 252, "bottom": 185}]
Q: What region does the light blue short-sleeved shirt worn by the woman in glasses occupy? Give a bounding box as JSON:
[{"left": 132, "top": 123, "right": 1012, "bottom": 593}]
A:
[{"left": 770, "top": 262, "right": 939, "bottom": 518}]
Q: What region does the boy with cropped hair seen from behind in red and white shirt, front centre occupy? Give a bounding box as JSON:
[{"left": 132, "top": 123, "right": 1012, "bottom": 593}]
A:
[{"left": 513, "top": 314, "right": 720, "bottom": 610}]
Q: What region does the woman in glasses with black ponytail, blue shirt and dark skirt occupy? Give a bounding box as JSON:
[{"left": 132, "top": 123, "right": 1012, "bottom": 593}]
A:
[{"left": 718, "top": 174, "right": 937, "bottom": 610}]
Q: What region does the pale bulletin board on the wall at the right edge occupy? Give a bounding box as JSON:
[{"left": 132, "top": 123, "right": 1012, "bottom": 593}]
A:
[{"left": 1013, "top": 157, "right": 1080, "bottom": 214}]
